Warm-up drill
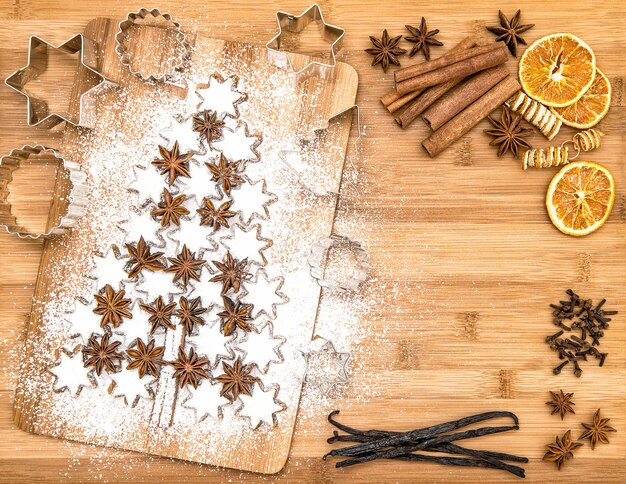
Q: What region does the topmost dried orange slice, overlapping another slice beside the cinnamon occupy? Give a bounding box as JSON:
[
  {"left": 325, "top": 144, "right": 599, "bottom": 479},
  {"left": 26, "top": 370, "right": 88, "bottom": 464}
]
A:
[{"left": 519, "top": 34, "right": 596, "bottom": 107}]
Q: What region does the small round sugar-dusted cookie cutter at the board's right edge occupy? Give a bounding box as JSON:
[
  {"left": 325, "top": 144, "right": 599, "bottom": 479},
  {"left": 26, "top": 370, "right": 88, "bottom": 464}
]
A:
[{"left": 307, "top": 235, "right": 372, "bottom": 291}]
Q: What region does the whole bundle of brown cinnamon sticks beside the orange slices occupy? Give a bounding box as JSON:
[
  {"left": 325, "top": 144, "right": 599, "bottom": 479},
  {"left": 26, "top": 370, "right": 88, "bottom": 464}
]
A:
[{"left": 381, "top": 37, "right": 520, "bottom": 157}]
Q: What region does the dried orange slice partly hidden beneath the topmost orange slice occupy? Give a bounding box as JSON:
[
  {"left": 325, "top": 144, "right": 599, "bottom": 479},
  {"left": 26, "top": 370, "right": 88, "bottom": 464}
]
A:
[{"left": 550, "top": 69, "right": 611, "bottom": 129}]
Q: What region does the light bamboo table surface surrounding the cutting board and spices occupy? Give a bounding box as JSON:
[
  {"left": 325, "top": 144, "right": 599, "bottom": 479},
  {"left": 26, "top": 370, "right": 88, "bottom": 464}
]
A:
[{"left": 0, "top": 0, "right": 626, "bottom": 482}]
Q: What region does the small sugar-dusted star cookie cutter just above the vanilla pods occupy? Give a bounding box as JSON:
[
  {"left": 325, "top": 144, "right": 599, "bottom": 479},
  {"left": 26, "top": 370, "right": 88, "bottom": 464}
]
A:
[{"left": 300, "top": 336, "right": 350, "bottom": 395}]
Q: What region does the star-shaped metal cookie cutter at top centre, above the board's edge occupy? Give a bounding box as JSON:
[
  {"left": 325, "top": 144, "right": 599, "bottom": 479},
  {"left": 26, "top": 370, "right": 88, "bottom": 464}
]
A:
[{"left": 265, "top": 3, "right": 345, "bottom": 84}]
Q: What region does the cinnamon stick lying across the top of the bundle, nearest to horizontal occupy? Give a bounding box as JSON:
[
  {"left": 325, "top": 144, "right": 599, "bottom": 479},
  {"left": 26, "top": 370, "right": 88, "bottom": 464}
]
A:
[{"left": 396, "top": 43, "right": 509, "bottom": 94}]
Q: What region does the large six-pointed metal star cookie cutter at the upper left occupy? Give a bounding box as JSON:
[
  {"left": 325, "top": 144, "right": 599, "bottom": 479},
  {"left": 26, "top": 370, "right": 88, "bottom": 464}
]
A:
[{"left": 4, "top": 34, "right": 117, "bottom": 129}]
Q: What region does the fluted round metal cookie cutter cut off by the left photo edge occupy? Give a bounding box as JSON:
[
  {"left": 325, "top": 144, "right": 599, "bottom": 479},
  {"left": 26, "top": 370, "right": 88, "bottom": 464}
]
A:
[{"left": 0, "top": 145, "right": 89, "bottom": 239}]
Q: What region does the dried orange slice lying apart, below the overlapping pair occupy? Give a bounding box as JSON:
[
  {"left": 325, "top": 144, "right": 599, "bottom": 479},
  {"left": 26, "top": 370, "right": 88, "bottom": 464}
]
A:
[{"left": 546, "top": 161, "right": 615, "bottom": 236}]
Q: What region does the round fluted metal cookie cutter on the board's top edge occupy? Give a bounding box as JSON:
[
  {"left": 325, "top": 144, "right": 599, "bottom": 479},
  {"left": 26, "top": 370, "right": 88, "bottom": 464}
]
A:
[{"left": 115, "top": 8, "right": 191, "bottom": 82}]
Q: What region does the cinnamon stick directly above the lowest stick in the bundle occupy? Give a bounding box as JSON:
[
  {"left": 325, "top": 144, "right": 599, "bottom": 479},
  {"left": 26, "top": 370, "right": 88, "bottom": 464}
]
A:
[{"left": 422, "top": 64, "right": 509, "bottom": 131}]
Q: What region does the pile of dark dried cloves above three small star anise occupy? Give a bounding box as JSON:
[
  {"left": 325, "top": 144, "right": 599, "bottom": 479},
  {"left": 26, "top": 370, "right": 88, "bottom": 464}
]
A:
[{"left": 546, "top": 289, "right": 617, "bottom": 377}]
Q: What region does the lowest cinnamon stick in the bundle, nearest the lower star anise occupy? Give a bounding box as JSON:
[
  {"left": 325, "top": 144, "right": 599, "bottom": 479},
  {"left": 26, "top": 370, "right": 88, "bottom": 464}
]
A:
[{"left": 422, "top": 76, "right": 521, "bottom": 157}]
